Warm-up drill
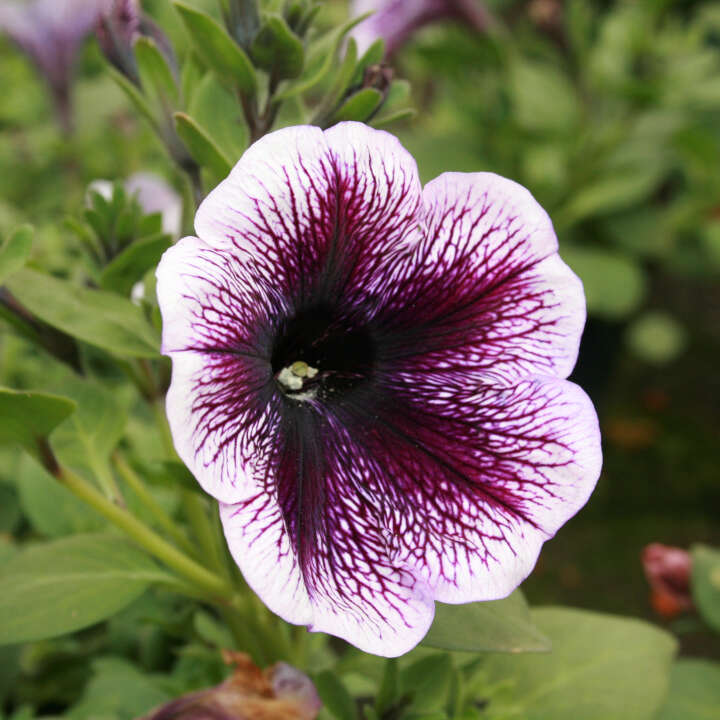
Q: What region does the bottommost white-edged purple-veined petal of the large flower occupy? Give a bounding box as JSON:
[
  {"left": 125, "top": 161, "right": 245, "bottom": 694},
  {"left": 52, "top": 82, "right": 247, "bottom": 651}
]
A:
[{"left": 220, "top": 410, "right": 434, "bottom": 656}]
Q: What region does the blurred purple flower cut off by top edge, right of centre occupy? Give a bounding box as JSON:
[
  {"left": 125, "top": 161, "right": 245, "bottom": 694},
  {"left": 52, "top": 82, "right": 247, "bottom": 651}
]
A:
[{"left": 350, "top": 0, "right": 490, "bottom": 55}]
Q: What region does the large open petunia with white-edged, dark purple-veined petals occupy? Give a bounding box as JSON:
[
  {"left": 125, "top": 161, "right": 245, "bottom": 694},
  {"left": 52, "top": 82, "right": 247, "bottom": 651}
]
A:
[{"left": 157, "top": 122, "right": 601, "bottom": 656}]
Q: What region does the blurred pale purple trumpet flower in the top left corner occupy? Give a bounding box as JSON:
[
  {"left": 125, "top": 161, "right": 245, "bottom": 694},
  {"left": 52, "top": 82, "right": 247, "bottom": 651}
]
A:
[{"left": 0, "top": 0, "right": 107, "bottom": 132}]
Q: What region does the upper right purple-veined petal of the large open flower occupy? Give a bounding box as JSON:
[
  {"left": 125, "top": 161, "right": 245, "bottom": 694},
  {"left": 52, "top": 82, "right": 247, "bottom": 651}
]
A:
[{"left": 374, "top": 173, "right": 585, "bottom": 379}]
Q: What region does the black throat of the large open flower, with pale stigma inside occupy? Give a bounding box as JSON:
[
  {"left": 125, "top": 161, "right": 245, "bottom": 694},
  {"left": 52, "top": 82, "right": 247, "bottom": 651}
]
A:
[{"left": 271, "top": 305, "right": 375, "bottom": 401}]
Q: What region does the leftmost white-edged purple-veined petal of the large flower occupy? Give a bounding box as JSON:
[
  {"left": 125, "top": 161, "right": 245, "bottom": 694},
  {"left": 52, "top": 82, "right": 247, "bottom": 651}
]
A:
[{"left": 157, "top": 237, "right": 277, "bottom": 502}]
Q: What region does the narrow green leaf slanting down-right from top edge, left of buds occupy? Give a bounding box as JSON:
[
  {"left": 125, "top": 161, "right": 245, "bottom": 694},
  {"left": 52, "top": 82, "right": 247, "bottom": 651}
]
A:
[{"left": 173, "top": 0, "right": 257, "bottom": 96}]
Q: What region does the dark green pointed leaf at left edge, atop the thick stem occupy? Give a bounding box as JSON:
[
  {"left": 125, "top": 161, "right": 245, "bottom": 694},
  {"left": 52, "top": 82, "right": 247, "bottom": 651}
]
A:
[{"left": 0, "top": 388, "right": 75, "bottom": 459}]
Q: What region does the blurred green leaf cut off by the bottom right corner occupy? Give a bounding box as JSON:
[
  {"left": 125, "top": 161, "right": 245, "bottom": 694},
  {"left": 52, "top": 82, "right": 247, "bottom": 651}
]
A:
[{"left": 657, "top": 658, "right": 720, "bottom": 720}]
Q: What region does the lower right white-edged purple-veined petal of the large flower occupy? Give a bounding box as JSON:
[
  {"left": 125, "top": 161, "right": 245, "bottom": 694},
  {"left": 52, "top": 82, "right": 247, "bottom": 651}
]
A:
[{"left": 373, "top": 377, "right": 602, "bottom": 603}]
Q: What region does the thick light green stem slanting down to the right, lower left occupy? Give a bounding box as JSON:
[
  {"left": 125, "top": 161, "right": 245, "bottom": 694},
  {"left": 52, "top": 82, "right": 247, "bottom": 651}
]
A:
[{"left": 56, "top": 468, "right": 235, "bottom": 603}]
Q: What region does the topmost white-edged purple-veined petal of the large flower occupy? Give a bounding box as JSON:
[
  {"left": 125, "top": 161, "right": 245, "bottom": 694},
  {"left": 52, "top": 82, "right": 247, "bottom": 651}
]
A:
[{"left": 195, "top": 122, "right": 421, "bottom": 312}]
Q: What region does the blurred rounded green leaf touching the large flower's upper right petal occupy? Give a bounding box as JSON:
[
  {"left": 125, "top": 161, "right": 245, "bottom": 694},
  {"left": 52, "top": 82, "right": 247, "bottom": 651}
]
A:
[{"left": 560, "top": 247, "right": 645, "bottom": 320}]
